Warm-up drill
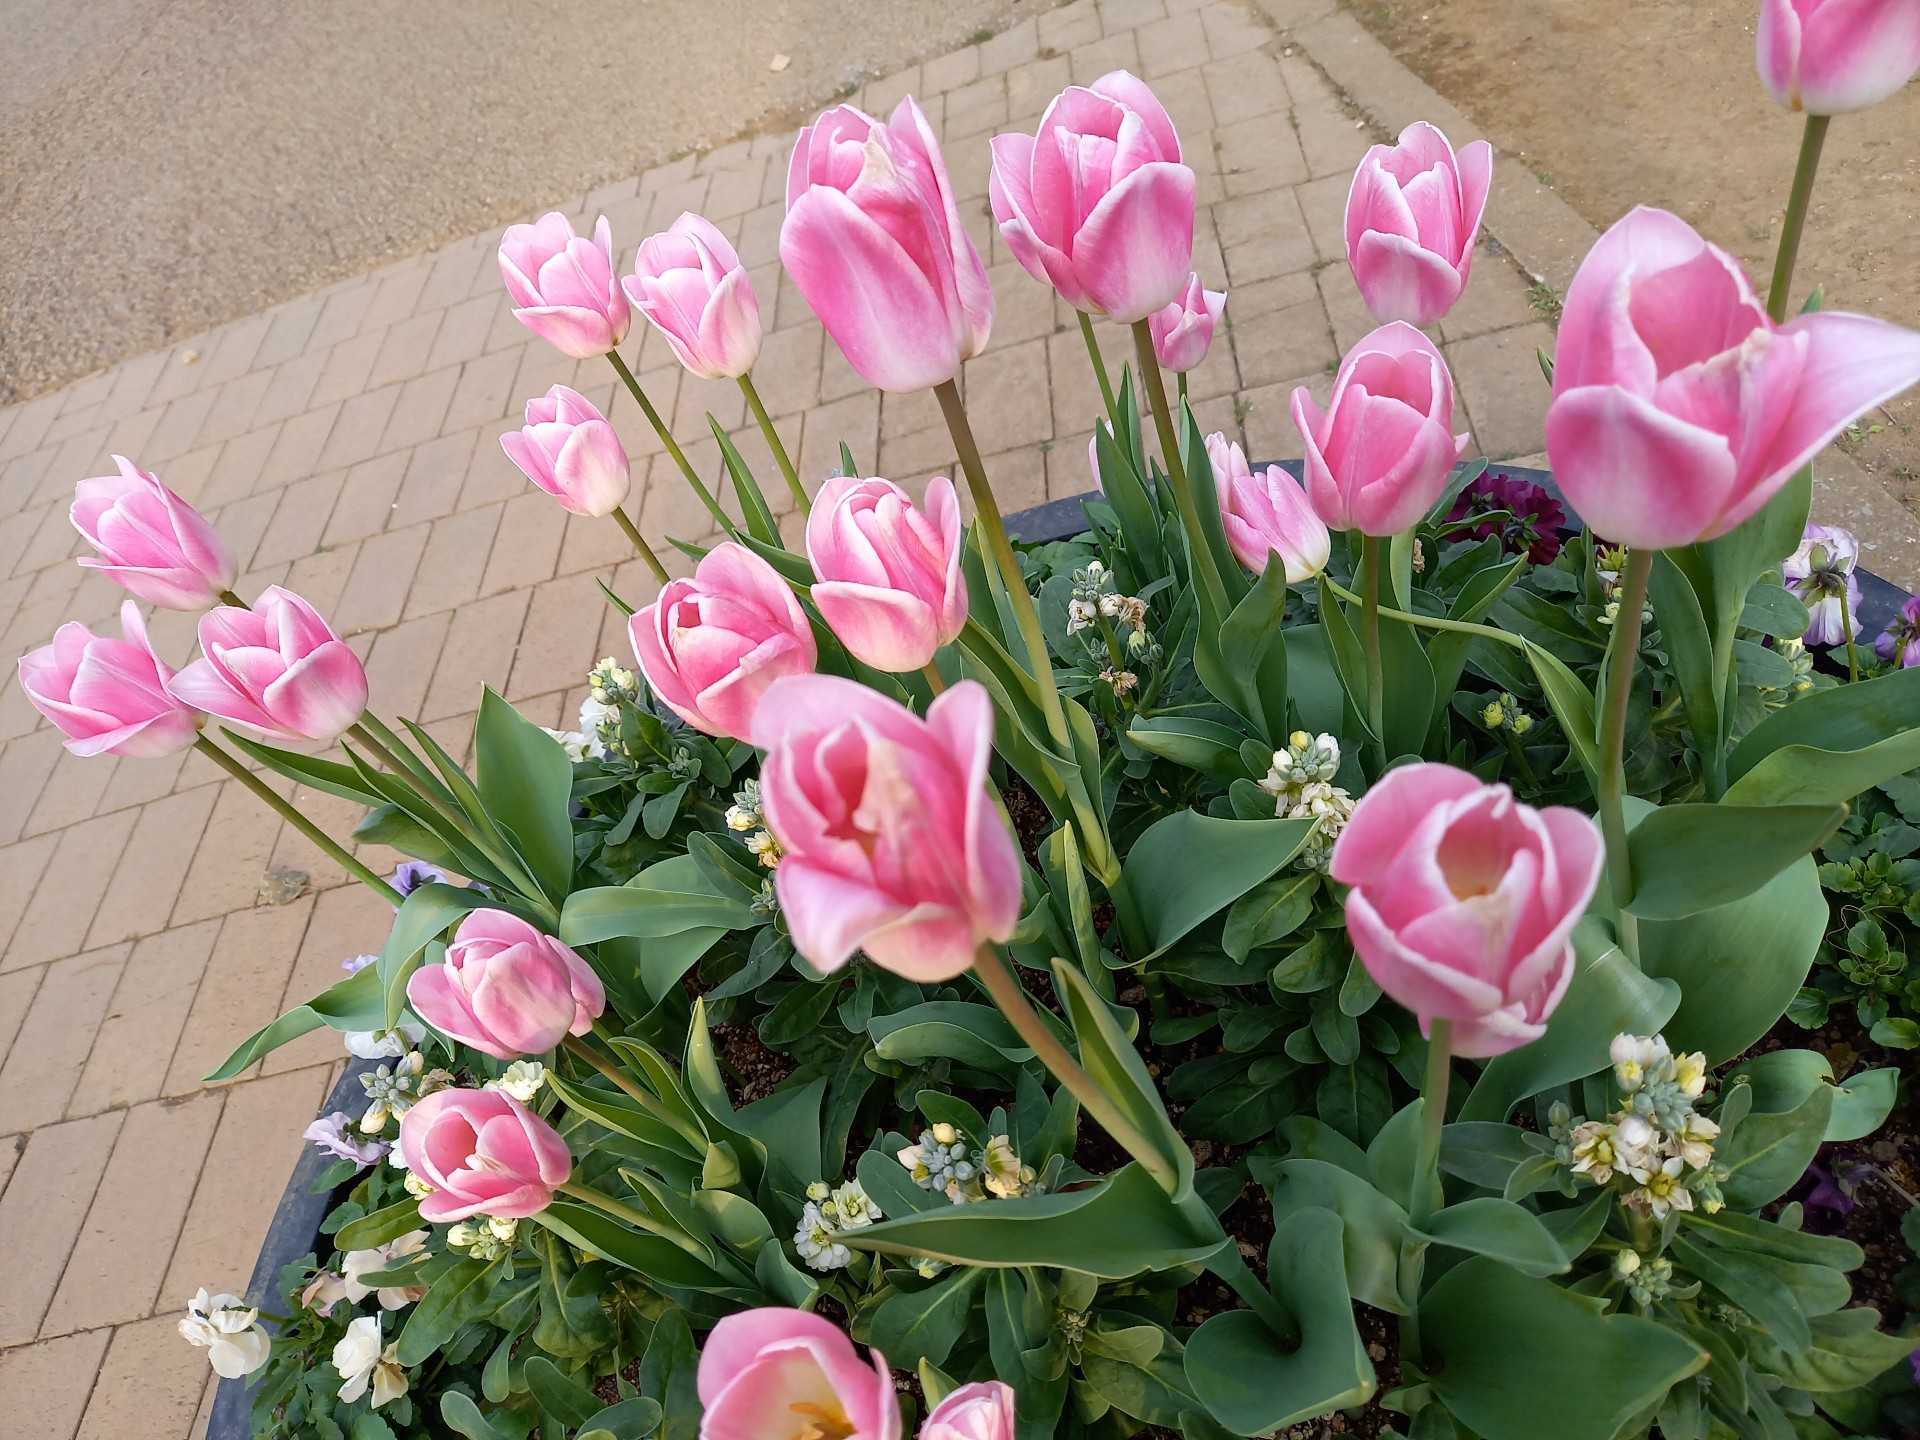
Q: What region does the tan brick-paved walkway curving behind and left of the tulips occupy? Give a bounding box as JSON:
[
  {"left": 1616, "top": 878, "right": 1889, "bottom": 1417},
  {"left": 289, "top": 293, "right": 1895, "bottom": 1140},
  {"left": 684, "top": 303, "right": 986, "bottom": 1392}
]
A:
[{"left": 0, "top": 0, "right": 1912, "bottom": 1440}]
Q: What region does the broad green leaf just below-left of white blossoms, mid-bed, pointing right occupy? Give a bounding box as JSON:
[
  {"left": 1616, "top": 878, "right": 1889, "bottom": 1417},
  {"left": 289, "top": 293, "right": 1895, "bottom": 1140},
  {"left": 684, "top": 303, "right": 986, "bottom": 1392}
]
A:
[{"left": 1125, "top": 810, "right": 1313, "bottom": 962}]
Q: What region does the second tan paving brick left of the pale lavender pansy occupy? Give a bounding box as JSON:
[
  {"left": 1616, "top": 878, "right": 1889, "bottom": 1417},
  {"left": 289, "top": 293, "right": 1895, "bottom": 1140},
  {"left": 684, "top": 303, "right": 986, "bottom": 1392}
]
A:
[{"left": 40, "top": 1094, "right": 221, "bottom": 1334}]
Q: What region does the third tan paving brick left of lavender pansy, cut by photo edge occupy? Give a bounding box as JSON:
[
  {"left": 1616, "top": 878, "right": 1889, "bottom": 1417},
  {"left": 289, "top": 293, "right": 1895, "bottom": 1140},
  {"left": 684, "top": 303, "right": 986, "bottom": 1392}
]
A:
[{"left": 0, "top": 1112, "right": 121, "bottom": 1351}]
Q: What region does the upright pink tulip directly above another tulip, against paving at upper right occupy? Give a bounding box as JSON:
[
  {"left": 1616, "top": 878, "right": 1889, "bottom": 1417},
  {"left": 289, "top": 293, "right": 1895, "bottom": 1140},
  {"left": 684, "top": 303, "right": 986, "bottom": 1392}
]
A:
[{"left": 1346, "top": 121, "right": 1494, "bottom": 324}]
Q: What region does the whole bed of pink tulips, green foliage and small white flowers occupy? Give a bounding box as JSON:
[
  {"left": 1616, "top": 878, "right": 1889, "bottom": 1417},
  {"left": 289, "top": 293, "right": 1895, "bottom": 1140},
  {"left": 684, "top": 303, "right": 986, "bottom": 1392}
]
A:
[{"left": 23, "top": 6, "right": 1920, "bottom": 1440}]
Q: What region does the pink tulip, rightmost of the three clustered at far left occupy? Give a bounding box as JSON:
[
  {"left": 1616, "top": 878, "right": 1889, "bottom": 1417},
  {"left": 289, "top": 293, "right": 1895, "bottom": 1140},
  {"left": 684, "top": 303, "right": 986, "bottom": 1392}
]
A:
[{"left": 167, "top": 586, "right": 367, "bottom": 743}]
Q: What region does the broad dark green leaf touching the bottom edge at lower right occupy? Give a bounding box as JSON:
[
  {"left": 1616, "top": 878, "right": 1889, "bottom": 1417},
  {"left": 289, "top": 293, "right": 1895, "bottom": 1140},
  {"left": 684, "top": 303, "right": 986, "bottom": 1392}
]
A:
[{"left": 1421, "top": 1256, "right": 1707, "bottom": 1440}]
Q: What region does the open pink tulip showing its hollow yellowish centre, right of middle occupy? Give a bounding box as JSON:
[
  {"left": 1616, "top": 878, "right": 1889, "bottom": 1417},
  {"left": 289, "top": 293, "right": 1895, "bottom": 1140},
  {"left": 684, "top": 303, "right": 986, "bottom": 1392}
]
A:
[{"left": 1332, "top": 764, "right": 1605, "bottom": 1058}]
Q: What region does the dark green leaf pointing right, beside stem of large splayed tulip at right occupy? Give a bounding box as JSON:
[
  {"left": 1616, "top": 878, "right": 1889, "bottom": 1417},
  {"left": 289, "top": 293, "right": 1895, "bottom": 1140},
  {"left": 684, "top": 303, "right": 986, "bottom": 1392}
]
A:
[{"left": 1626, "top": 804, "right": 1847, "bottom": 920}]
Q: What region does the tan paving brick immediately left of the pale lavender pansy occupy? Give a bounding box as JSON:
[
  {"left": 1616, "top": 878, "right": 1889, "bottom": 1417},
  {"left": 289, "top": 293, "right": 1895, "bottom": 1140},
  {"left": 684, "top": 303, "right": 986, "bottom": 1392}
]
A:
[{"left": 161, "top": 1068, "right": 326, "bottom": 1296}]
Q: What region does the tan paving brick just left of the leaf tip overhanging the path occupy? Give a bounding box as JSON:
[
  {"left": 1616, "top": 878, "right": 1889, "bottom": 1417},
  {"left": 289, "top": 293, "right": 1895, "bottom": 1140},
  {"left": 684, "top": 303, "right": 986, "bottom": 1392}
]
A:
[{"left": 67, "top": 920, "right": 221, "bottom": 1116}]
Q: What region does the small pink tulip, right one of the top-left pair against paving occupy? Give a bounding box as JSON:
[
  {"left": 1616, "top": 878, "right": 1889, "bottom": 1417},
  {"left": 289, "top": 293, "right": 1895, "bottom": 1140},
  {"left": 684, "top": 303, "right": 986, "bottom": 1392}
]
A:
[{"left": 620, "top": 213, "right": 760, "bottom": 380}]
